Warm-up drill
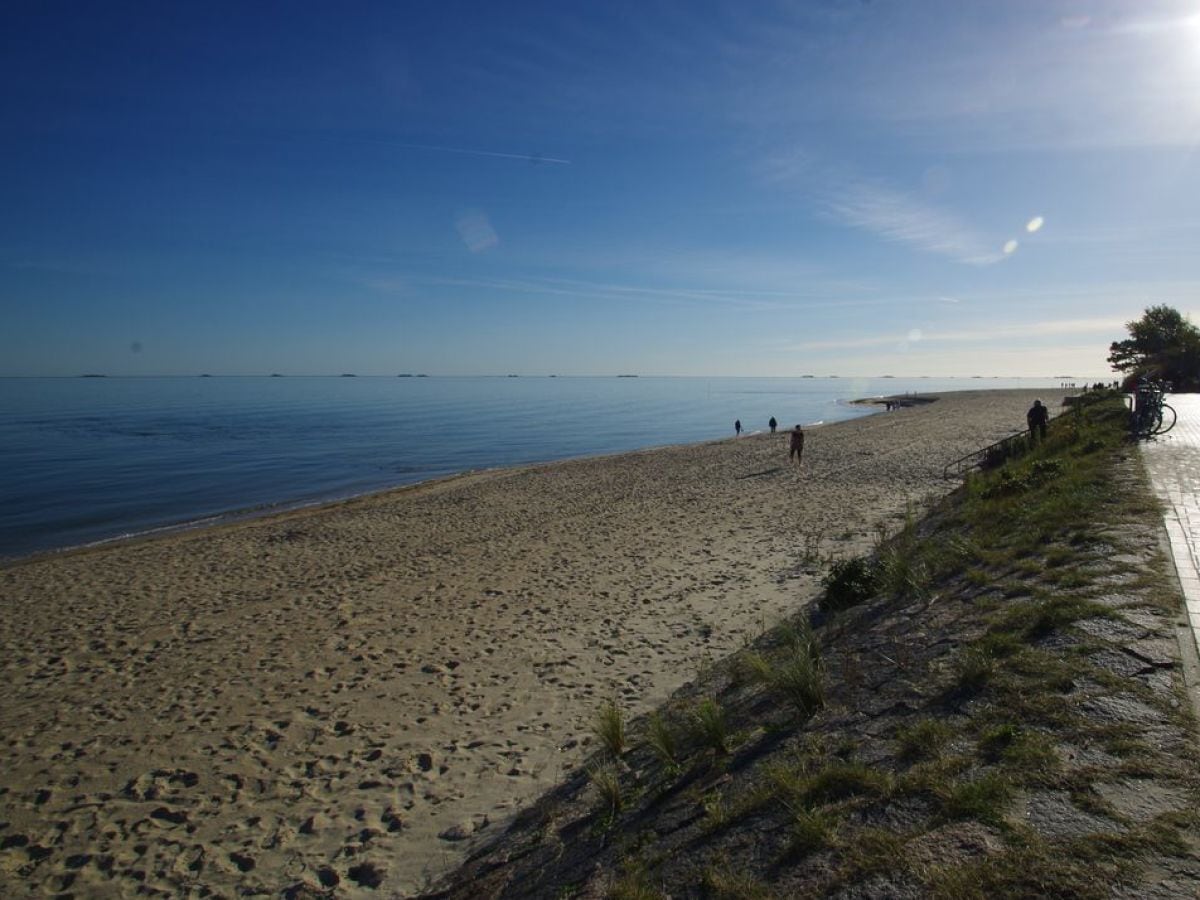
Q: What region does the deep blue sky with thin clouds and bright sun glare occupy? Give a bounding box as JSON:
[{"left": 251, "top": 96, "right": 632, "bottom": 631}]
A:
[{"left": 0, "top": 0, "right": 1200, "bottom": 377}]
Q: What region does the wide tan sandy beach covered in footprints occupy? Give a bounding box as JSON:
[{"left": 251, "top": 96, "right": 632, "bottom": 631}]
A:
[{"left": 0, "top": 390, "right": 1062, "bottom": 896}]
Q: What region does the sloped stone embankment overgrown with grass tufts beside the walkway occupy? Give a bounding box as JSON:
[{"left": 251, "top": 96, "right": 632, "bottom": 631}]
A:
[{"left": 431, "top": 400, "right": 1200, "bottom": 900}]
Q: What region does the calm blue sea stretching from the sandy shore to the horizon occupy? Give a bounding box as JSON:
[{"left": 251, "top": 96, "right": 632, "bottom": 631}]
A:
[{"left": 0, "top": 377, "right": 1057, "bottom": 557}]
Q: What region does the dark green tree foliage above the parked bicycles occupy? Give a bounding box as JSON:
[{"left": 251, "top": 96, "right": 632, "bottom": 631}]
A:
[{"left": 1109, "top": 305, "right": 1200, "bottom": 391}]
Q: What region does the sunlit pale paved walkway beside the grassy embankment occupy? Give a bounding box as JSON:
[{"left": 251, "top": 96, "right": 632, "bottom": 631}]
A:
[{"left": 1141, "top": 394, "right": 1200, "bottom": 647}]
